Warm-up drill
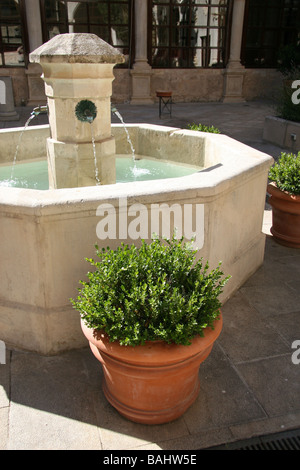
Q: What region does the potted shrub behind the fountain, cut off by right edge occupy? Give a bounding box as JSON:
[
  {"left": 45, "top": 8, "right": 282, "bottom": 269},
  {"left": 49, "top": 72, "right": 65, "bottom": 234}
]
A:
[{"left": 267, "top": 152, "right": 300, "bottom": 248}]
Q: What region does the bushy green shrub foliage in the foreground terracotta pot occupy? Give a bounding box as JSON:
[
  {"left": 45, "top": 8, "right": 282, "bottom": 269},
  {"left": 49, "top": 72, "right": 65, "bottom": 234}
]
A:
[{"left": 70, "top": 236, "right": 230, "bottom": 346}]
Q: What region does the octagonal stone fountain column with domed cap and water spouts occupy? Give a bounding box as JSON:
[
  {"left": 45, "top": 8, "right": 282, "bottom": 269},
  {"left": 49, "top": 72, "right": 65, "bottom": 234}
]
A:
[{"left": 30, "top": 33, "right": 124, "bottom": 188}]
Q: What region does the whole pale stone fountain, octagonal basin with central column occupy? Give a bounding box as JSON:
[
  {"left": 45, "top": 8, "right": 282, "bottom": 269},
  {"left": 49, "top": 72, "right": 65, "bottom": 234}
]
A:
[{"left": 0, "top": 34, "right": 273, "bottom": 354}]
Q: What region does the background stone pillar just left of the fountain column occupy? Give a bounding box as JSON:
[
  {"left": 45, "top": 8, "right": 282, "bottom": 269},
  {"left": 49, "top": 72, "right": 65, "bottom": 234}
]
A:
[{"left": 25, "top": 0, "right": 46, "bottom": 106}]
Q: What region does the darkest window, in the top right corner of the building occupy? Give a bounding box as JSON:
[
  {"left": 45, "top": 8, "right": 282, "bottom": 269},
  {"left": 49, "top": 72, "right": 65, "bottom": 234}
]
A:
[{"left": 241, "top": 0, "right": 300, "bottom": 68}]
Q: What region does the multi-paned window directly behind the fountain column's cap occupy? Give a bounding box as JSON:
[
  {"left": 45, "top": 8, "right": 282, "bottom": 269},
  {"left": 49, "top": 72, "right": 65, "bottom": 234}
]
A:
[{"left": 40, "top": 0, "right": 132, "bottom": 65}]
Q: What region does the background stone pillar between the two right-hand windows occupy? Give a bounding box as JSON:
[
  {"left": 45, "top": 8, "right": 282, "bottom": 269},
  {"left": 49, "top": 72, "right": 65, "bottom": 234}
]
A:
[{"left": 223, "top": 0, "right": 245, "bottom": 103}]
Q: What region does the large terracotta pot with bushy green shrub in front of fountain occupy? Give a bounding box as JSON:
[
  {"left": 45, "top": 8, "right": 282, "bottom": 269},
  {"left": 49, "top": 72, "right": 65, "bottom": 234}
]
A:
[{"left": 71, "top": 236, "right": 229, "bottom": 424}]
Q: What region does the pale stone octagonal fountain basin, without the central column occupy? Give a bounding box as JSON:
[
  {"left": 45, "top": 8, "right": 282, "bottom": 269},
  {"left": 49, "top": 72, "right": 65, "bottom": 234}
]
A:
[{"left": 0, "top": 124, "right": 273, "bottom": 354}]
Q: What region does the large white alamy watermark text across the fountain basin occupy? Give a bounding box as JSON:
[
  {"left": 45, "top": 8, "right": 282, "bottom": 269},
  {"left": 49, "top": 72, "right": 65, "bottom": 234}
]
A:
[{"left": 96, "top": 198, "right": 204, "bottom": 249}]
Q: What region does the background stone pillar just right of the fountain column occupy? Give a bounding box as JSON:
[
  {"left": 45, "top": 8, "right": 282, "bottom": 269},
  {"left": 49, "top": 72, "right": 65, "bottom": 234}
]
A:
[{"left": 130, "top": 0, "right": 154, "bottom": 104}]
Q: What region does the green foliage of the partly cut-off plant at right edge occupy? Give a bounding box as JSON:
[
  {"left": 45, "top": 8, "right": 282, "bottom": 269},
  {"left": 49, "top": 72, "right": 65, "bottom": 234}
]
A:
[{"left": 269, "top": 152, "right": 300, "bottom": 195}]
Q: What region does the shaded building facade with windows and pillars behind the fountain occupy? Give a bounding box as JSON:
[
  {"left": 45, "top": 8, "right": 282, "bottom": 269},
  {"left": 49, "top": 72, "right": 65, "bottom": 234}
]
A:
[{"left": 0, "top": 0, "right": 300, "bottom": 106}]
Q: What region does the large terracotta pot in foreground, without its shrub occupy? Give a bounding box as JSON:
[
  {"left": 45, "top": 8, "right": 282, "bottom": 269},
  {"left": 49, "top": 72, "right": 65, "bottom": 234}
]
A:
[{"left": 81, "top": 315, "right": 222, "bottom": 424}]
